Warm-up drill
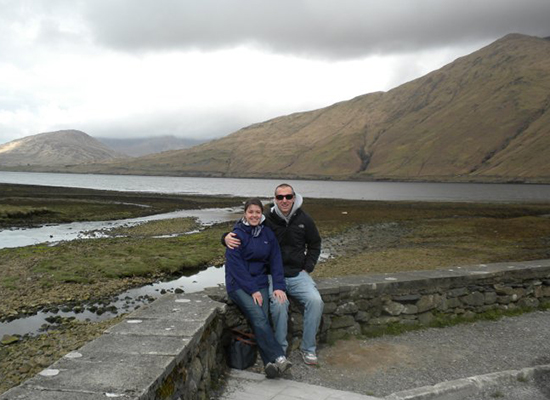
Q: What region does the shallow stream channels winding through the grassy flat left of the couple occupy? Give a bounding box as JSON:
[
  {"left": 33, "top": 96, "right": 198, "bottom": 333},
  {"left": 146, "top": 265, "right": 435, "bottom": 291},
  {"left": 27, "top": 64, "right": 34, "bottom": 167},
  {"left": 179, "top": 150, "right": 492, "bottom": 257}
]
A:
[{"left": 0, "top": 208, "right": 239, "bottom": 338}]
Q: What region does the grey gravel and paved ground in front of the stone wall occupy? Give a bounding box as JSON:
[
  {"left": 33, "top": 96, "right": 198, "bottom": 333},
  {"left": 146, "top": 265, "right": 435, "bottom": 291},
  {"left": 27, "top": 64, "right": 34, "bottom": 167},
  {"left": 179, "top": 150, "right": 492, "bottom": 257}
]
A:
[{"left": 218, "top": 311, "right": 550, "bottom": 400}]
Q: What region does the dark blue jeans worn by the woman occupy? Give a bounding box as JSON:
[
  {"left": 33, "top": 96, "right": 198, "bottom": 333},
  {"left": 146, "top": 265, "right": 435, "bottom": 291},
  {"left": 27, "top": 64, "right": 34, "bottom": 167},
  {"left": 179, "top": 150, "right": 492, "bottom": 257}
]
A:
[{"left": 228, "top": 288, "right": 285, "bottom": 365}]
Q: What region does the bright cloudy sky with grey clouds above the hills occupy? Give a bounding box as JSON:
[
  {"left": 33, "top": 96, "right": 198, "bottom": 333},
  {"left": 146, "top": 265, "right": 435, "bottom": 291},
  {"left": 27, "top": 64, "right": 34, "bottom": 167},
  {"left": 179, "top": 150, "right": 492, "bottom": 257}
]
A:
[{"left": 0, "top": 0, "right": 550, "bottom": 144}]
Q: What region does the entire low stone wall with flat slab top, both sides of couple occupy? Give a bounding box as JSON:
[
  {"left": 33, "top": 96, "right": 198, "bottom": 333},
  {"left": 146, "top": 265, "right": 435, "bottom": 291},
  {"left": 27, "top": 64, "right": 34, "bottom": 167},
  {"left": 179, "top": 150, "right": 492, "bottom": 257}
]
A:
[{"left": 4, "top": 260, "right": 550, "bottom": 400}]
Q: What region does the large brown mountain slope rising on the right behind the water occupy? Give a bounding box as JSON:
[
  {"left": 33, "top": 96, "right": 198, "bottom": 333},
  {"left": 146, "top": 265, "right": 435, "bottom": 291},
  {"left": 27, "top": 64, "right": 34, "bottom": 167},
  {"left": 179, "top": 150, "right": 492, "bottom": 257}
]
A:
[{"left": 4, "top": 34, "right": 550, "bottom": 182}]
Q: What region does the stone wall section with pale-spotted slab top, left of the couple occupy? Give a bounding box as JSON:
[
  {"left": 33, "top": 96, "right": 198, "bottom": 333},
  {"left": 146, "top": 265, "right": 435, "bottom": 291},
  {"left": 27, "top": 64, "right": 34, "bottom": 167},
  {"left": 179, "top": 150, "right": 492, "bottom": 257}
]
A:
[{"left": 0, "top": 293, "right": 231, "bottom": 400}]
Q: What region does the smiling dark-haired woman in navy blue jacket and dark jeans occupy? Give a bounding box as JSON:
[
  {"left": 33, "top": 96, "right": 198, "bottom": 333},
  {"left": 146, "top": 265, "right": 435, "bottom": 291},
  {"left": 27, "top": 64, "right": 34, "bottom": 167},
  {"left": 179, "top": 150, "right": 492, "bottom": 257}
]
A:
[{"left": 225, "top": 198, "right": 292, "bottom": 378}]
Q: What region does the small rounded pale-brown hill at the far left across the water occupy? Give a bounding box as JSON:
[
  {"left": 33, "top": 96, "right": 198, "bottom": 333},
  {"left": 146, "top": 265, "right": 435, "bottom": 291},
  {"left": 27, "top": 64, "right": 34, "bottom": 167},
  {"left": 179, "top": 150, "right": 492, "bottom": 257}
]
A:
[{"left": 0, "top": 130, "right": 123, "bottom": 169}]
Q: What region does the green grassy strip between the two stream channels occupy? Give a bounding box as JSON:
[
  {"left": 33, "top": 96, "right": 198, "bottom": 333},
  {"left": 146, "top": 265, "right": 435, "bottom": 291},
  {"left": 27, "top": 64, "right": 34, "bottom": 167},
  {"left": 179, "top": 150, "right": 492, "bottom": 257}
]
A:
[{"left": 24, "top": 222, "right": 233, "bottom": 286}]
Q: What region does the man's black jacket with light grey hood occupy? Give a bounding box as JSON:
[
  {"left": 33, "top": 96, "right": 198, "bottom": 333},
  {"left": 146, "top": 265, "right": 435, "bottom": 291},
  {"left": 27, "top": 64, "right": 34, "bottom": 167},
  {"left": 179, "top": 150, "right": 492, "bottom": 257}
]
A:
[{"left": 265, "top": 194, "right": 321, "bottom": 277}]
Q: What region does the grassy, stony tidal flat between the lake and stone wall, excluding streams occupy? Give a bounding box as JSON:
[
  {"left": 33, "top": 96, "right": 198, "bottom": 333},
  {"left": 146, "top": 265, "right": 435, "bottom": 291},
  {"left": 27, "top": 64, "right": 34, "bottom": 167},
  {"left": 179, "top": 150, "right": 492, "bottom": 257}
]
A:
[{"left": 0, "top": 184, "right": 550, "bottom": 393}]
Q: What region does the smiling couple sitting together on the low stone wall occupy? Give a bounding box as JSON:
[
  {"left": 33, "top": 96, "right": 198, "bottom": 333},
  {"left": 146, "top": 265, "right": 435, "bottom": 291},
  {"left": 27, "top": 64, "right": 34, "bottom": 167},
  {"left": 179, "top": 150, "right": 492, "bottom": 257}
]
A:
[{"left": 223, "top": 184, "right": 323, "bottom": 378}]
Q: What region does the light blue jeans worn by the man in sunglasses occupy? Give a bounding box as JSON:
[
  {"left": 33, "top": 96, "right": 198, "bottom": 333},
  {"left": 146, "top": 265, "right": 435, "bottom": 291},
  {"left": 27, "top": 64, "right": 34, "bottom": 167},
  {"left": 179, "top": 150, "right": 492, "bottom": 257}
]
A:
[{"left": 269, "top": 271, "right": 324, "bottom": 353}]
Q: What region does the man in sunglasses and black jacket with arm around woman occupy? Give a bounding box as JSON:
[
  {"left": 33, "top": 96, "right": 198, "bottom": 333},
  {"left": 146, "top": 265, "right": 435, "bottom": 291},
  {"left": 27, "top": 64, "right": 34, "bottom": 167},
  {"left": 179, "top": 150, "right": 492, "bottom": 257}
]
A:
[{"left": 224, "top": 183, "right": 324, "bottom": 365}]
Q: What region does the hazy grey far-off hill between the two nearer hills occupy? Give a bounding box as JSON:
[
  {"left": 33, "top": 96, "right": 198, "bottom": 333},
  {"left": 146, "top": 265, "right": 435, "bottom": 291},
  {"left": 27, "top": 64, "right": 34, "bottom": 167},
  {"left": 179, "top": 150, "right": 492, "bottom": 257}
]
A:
[{"left": 96, "top": 135, "right": 205, "bottom": 157}]
